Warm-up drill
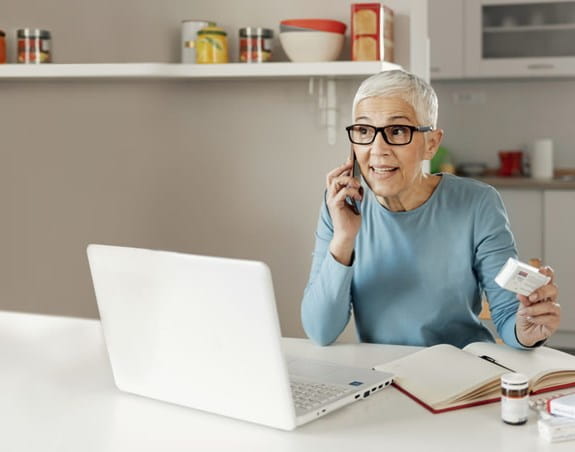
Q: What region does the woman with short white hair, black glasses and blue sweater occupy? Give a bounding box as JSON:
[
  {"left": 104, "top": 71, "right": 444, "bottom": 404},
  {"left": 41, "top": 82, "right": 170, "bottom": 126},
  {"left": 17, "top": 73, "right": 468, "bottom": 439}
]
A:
[{"left": 302, "top": 71, "right": 560, "bottom": 348}]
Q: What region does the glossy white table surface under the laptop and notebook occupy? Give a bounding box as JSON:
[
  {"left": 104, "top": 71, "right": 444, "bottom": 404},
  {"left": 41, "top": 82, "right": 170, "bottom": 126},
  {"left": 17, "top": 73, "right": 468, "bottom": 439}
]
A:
[{"left": 0, "top": 312, "right": 575, "bottom": 452}]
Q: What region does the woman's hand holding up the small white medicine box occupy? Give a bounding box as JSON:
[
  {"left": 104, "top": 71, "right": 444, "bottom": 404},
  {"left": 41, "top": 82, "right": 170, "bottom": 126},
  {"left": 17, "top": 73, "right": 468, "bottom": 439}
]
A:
[{"left": 515, "top": 267, "right": 561, "bottom": 347}]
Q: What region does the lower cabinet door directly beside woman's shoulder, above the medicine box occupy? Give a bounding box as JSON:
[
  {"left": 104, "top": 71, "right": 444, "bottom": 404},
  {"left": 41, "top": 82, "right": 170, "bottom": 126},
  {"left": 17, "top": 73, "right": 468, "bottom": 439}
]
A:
[{"left": 499, "top": 189, "right": 544, "bottom": 262}]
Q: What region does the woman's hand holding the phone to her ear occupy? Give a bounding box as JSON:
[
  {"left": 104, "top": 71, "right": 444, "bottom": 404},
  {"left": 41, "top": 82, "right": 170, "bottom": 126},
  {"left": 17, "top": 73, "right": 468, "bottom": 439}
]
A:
[{"left": 326, "top": 159, "right": 363, "bottom": 265}]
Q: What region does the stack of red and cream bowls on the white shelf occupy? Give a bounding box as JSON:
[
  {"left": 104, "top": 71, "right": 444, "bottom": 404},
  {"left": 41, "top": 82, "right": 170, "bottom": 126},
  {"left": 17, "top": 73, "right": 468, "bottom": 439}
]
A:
[{"left": 280, "top": 19, "right": 347, "bottom": 62}]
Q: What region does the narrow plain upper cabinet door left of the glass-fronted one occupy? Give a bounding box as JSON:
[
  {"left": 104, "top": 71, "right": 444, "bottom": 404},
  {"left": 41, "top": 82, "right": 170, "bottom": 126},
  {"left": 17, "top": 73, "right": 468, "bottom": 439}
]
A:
[{"left": 429, "top": 0, "right": 463, "bottom": 80}]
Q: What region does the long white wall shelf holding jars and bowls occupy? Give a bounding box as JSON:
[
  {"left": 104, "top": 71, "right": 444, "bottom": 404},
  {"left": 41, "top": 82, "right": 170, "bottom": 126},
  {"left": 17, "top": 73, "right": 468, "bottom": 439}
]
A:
[{"left": 0, "top": 61, "right": 401, "bottom": 80}]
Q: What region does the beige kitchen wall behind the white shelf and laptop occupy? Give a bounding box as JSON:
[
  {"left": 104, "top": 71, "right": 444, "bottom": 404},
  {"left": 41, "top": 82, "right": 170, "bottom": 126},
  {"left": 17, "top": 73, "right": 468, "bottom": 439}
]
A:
[{"left": 0, "top": 0, "right": 418, "bottom": 336}]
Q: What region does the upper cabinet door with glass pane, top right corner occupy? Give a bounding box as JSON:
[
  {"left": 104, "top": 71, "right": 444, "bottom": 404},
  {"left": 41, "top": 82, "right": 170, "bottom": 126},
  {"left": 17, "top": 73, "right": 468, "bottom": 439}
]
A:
[{"left": 464, "top": 0, "right": 575, "bottom": 77}]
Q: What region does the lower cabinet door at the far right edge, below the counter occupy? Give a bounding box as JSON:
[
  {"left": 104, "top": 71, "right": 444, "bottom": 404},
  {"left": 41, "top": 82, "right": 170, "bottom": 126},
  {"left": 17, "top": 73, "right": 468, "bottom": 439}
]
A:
[{"left": 544, "top": 190, "right": 575, "bottom": 332}]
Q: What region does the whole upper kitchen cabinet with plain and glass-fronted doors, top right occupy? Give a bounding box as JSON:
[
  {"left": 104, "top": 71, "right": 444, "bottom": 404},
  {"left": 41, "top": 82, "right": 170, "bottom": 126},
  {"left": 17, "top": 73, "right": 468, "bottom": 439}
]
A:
[{"left": 429, "top": 0, "right": 575, "bottom": 79}]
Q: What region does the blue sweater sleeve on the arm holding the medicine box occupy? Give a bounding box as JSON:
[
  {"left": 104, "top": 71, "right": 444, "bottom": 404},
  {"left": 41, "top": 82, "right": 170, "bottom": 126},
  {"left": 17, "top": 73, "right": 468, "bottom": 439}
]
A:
[{"left": 475, "top": 187, "right": 529, "bottom": 349}]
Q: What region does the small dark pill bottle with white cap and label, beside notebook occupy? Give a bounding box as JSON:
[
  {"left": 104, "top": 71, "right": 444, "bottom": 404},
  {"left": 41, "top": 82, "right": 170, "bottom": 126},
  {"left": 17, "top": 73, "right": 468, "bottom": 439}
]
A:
[{"left": 501, "top": 373, "right": 529, "bottom": 425}]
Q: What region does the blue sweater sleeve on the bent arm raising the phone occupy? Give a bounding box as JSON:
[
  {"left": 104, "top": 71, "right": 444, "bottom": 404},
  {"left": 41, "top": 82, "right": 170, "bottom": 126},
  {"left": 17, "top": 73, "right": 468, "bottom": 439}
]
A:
[{"left": 301, "top": 194, "right": 355, "bottom": 345}]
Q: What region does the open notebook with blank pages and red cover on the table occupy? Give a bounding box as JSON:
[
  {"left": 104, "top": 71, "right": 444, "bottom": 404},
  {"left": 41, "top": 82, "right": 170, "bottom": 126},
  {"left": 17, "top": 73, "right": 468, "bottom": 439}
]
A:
[{"left": 375, "top": 342, "right": 575, "bottom": 413}]
